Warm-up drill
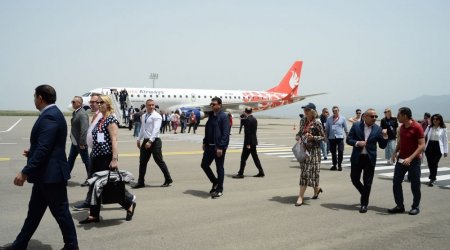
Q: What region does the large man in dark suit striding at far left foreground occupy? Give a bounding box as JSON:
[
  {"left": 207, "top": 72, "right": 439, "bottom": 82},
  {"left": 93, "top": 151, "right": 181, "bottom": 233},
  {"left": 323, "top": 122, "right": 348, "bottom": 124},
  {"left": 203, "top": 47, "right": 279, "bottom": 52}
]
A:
[{"left": 2, "top": 85, "right": 78, "bottom": 249}]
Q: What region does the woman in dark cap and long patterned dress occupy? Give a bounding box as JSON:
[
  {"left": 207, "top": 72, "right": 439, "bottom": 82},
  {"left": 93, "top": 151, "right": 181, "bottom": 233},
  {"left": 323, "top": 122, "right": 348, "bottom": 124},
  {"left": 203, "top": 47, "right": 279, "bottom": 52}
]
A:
[{"left": 295, "top": 103, "right": 325, "bottom": 206}]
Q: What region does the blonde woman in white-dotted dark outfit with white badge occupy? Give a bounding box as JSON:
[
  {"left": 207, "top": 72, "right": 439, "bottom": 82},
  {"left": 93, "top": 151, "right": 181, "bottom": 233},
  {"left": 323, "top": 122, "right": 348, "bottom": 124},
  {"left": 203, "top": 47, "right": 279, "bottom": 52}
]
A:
[{"left": 79, "top": 95, "right": 136, "bottom": 224}]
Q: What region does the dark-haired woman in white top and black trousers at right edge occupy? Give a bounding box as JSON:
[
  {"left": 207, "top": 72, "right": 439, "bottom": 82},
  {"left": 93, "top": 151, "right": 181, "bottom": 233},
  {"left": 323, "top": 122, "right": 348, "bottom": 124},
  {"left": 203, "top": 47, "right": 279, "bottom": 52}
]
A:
[{"left": 425, "top": 114, "right": 448, "bottom": 187}]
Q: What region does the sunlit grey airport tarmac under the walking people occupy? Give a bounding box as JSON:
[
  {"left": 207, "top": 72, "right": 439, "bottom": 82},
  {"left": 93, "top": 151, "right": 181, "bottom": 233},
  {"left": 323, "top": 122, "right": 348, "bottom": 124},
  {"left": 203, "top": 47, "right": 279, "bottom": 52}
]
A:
[{"left": 0, "top": 117, "right": 450, "bottom": 249}]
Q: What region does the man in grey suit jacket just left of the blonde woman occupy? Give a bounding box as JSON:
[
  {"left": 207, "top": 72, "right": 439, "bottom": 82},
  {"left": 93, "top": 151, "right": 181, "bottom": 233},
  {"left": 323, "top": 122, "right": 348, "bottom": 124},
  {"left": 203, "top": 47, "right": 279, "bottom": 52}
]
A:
[{"left": 68, "top": 96, "right": 90, "bottom": 182}]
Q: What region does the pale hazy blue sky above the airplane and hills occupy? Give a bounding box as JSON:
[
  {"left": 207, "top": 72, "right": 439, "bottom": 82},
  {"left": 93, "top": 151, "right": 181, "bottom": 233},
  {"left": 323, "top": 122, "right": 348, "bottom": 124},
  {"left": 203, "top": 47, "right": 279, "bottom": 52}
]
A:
[{"left": 0, "top": 0, "right": 450, "bottom": 114}]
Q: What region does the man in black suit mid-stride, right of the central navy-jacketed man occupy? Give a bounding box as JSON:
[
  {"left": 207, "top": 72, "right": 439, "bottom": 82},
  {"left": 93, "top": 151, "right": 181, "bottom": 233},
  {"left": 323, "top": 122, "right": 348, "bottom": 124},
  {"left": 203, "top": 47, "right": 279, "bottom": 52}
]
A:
[{"left": 233, "top": 108, "right": 265, "bottom": 179}]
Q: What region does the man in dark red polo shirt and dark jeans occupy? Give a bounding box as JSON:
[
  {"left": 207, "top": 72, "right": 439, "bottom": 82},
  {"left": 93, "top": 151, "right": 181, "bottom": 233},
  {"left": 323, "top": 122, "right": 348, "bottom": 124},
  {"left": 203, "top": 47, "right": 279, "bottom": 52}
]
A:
[{"left": 388, "top": 107, "right": 425, "bottom": 215}]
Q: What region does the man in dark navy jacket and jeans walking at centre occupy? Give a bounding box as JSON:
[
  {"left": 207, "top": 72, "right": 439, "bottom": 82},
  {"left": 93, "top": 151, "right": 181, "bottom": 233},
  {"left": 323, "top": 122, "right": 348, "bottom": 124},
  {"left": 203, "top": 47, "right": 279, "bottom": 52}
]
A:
[{"left": 201, "top": 97, "right": 230, "bottom": 199}]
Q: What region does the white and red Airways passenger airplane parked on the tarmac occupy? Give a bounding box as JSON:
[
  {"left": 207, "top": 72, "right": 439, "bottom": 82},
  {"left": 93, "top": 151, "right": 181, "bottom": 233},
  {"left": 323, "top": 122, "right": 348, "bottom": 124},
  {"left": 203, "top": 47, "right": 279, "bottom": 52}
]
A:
[{"left": 77, "top": 61, "right": 325, "bottom": 124}]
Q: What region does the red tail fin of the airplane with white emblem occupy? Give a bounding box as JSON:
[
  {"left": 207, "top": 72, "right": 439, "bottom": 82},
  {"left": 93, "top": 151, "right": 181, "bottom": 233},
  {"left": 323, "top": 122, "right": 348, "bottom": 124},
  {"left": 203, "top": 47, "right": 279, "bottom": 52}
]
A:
[{"left": 267, "top": 61, "right": 303, "bottom": 96}]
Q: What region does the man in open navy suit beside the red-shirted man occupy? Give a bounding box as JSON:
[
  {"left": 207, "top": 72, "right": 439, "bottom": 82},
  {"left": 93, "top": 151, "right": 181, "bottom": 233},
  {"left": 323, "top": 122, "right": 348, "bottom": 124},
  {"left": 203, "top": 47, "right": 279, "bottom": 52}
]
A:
[{"left": 346, "top": 109, "right": 388, "bottom": 213}]
